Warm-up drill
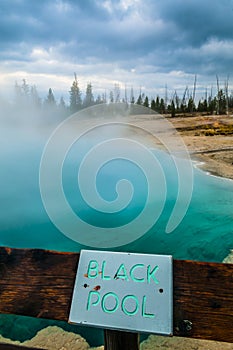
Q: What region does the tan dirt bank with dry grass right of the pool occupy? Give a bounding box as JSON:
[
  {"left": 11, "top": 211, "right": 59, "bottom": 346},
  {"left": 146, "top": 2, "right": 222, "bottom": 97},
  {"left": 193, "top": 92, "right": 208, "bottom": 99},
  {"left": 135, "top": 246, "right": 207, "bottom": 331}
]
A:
[{"left": 125, "top": 115, "right": 233, "bottom": 179}]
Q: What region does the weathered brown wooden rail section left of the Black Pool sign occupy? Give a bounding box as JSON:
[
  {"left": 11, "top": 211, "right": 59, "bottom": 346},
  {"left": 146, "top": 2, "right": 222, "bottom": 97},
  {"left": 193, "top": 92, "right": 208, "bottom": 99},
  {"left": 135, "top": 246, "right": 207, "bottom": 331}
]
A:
[{"left": 0, "top": 248, "right": 79, "bottom": 320}]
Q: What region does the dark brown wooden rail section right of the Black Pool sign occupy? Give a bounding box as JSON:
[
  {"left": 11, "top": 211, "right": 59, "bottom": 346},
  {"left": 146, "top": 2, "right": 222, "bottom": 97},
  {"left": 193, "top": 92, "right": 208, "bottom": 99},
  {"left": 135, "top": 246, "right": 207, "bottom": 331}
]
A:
[{"left": 173, "top": 260, "right": 233, "bottom": 342}]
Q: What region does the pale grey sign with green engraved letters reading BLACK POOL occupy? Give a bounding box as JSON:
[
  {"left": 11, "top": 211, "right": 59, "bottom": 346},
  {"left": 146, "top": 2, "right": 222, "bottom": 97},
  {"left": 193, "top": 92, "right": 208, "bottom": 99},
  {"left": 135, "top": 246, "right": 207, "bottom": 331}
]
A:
[{"left": 69, "top": 250, "right": 173, "bottom": 335}]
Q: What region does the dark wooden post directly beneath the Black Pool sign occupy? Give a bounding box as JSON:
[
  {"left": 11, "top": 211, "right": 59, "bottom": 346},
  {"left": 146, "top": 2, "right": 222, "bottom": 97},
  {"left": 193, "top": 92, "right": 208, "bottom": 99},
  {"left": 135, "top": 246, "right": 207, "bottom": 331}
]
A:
[{"left": 104, "top": 330, "right": 139, "bottom": 350}]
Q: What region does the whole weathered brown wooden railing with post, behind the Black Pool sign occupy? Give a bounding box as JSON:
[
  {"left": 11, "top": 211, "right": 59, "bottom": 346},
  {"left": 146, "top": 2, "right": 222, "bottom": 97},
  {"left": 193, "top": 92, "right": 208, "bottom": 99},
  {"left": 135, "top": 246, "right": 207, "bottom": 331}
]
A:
[{"left": 0, "top": 247, "right": 233, "bottom": 350}]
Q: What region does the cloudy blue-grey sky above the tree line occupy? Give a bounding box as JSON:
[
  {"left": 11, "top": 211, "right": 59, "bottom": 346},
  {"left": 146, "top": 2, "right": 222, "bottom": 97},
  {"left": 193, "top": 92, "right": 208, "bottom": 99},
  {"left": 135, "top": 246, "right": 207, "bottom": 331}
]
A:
[{"left": 0, "top": 0, "right": 233, "bottom": 100}]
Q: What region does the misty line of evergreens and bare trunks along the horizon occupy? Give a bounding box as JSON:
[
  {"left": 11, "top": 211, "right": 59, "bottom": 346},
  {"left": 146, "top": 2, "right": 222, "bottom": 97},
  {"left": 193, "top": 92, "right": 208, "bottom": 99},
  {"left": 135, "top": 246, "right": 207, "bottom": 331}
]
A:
[{"left": 10, "top": 74, "right": 233, "bottom": 118}]
